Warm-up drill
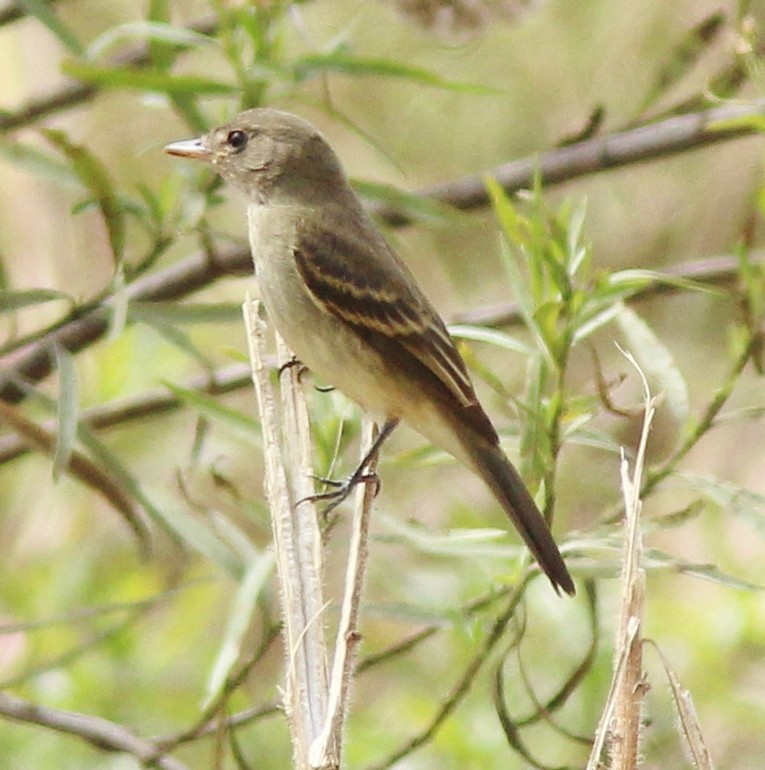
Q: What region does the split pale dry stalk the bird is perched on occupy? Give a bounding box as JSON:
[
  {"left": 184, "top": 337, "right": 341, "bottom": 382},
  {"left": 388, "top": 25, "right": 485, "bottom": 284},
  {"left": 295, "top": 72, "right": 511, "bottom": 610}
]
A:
[{"left": 243, "top": 298, "right": 375, "bottom": 770}]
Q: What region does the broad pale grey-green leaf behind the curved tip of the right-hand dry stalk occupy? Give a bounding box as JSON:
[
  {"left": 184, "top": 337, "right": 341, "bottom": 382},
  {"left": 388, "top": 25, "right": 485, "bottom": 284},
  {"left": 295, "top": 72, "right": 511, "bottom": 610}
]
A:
[{"left": 615, "top": 304, "right": 690, "bottom": 425}]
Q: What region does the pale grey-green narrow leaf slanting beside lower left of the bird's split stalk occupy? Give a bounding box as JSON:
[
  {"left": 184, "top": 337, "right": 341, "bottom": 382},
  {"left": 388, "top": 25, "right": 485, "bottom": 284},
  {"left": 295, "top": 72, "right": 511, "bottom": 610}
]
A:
[{"left": 202, "top": 551, "right": 276, "bottom": 709}]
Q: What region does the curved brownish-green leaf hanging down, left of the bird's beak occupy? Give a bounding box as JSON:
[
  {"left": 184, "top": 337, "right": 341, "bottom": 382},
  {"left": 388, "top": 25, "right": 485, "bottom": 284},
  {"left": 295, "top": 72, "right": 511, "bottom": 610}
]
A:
[{"left": 41, "top": 128, "right": 125, "bottom": 265}]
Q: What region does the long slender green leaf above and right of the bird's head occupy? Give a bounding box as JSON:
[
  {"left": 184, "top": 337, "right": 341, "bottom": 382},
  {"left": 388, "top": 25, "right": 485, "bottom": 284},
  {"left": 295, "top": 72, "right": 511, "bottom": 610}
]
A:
[{"left": 292, "top": 52, "right": 502, "bottom": 96}]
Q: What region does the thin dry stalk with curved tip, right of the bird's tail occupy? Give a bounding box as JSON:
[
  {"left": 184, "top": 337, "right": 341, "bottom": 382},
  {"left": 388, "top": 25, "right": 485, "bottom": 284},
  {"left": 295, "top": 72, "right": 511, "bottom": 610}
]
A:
[{"left": 587, "top": 352, "right": 654, "bottom": 770}]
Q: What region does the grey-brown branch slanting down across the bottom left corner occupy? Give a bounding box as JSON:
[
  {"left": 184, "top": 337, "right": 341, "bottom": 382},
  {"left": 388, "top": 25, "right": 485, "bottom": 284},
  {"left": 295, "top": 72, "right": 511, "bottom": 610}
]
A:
[{"left": 0, "top": 692, "right": 188, "bottom": 770}]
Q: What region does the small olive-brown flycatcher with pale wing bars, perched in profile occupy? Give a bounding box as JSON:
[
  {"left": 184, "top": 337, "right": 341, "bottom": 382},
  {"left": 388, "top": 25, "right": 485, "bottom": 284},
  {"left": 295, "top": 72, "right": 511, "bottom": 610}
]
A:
[{"left": 165, "top": 109, "right": 575, "bottom": 594}]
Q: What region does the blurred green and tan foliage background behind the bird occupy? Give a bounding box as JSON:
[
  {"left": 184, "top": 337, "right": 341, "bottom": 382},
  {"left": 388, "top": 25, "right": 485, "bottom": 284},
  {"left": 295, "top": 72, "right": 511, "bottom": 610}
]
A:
[{"left": 0, "top": 0, "right": 765, "bottom": 770}]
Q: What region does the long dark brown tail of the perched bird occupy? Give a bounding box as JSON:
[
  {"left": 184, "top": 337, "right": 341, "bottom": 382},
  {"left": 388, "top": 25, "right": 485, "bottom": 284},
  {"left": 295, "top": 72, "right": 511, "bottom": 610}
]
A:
[{"left": 463, "top": 435, "right": 576, "bottom": 596}]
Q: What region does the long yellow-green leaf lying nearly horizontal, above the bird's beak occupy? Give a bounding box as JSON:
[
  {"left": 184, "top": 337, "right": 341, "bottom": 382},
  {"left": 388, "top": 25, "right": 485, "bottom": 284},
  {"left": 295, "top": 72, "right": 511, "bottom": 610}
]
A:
[{"left": 61, "top": 61, "right": 239, "bottom": 96}]
